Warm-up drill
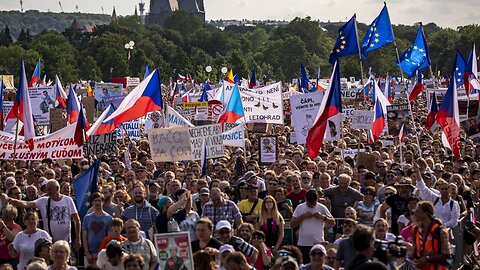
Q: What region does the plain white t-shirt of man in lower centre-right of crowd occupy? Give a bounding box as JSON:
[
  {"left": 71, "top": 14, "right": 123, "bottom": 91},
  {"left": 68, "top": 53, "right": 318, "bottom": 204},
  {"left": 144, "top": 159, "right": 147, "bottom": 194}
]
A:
[{"left": 293, "top": 203, "right": 332, "bottom": 247}]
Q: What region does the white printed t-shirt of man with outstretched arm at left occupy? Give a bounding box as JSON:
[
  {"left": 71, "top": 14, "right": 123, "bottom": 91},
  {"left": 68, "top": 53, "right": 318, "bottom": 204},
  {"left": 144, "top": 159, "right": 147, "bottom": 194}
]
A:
[{"left": 35, "top": 195, "right": 78, "bottom": 242}]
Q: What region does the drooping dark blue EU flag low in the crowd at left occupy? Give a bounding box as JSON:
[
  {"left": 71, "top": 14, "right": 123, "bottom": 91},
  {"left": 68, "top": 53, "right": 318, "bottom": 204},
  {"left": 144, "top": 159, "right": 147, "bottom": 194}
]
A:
[{"left": 73, "top": 159, "right": 100, "bottom": 220}]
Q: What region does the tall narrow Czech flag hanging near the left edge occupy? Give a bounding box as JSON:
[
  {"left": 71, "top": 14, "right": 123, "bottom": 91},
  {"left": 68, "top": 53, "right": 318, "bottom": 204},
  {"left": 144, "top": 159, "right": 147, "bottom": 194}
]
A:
[{"left": 5, "top": 60, "right": 35, "bottom": 151}]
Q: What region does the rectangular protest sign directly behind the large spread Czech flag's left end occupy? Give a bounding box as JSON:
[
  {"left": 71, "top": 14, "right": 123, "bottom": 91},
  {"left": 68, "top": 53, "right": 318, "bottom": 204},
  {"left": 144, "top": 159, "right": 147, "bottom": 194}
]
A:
[{"left": 93, "top": 82, "right": 125, "bottom": 111}]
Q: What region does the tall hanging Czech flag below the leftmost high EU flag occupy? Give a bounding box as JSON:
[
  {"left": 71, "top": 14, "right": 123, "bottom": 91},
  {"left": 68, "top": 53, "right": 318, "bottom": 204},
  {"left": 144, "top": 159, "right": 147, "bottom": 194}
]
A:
[{"left": 307, "top": 61, "right": 342, "bottom": 159}]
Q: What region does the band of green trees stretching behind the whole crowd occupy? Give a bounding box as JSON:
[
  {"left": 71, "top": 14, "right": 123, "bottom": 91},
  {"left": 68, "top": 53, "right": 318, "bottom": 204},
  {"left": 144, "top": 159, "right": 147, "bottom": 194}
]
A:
[{"left": 0, "top": 11, "right": 480, "bottom": 85}]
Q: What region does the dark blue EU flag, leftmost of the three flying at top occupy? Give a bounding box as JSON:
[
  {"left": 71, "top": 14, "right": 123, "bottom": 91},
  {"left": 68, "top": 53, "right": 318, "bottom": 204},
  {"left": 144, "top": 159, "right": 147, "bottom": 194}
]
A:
[{"left": 329, "top": 14, "right": 358, "bottom": 65}]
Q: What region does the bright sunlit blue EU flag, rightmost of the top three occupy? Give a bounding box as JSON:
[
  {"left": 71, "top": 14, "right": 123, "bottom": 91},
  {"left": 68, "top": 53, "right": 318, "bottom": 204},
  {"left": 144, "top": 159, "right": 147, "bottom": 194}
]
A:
[{"left": 397, "top": 25, "right": 431, "bottom": 78}]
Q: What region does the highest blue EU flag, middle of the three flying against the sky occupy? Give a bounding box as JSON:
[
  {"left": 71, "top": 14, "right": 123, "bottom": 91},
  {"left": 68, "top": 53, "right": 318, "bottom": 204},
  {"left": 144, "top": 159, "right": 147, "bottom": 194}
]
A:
[{"left": 361, "top": 4, "right": 395, "bottom": 59}]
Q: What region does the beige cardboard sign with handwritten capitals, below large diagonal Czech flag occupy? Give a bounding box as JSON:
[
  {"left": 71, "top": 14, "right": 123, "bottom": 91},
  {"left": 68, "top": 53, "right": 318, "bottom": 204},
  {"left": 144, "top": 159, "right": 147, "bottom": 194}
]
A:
[{"left": 147, "top": 127, "right": 192, "bottom": 162}]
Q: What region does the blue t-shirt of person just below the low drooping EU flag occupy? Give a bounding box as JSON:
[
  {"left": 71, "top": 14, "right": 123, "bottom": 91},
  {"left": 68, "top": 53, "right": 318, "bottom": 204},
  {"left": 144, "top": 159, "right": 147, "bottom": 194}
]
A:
[{"left": 82, "top": 212, "right": 113, "bottom": 253}]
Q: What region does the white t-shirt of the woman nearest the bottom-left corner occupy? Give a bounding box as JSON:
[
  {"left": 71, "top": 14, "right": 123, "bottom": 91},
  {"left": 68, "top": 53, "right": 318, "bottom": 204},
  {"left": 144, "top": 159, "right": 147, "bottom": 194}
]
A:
[{"left": 12, "top": 229, "right": 52, "bottom": 270}]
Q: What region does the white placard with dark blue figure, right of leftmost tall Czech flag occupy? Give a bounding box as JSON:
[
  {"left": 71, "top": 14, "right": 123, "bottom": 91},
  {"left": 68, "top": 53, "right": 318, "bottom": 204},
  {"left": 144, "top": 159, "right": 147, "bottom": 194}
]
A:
[{"left": 28, "top": 86, "right": 55, "bottom": 125}]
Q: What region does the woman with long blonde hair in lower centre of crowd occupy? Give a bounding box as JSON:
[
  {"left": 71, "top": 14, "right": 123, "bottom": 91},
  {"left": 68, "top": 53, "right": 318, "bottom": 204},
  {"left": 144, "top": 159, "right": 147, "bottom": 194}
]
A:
[{"left": 256, "top": 195, "right": 285, "bottom": 253}]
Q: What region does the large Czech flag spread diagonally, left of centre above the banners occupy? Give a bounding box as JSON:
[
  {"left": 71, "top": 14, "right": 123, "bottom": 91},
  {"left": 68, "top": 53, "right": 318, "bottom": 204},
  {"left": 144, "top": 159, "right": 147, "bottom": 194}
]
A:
[{"left": 105, "top": 69, "right": 163, "bottom": 128}]
